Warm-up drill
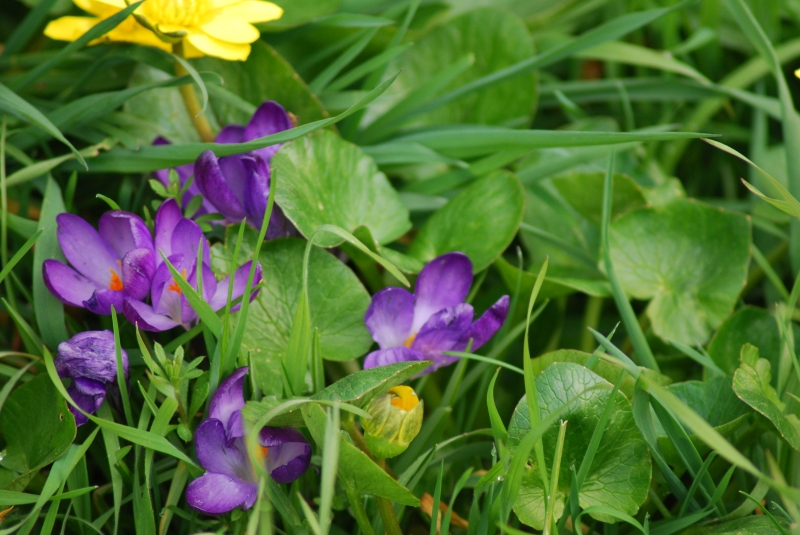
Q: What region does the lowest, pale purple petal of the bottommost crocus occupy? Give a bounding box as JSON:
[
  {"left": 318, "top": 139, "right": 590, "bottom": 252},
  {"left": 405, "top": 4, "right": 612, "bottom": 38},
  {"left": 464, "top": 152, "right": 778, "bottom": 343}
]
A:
[{"left": 186, "top": 472, "right": 258, "bottom": 515}]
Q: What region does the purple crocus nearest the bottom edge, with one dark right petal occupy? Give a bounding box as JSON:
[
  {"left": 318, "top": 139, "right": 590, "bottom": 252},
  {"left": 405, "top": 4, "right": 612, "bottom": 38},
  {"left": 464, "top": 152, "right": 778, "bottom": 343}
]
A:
[{"left": 186, "top": 367, "right": 311, "bottom": 515}]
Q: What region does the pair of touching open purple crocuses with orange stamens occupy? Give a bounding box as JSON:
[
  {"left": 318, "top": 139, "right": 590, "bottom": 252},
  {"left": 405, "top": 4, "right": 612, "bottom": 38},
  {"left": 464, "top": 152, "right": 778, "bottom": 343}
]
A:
[{"left": 42, "top": 199, "right": 261, "bottom": 331}]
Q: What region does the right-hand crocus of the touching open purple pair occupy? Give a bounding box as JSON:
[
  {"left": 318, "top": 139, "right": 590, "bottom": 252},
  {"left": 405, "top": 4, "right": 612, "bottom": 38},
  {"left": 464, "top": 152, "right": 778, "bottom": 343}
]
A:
[{"left": 123, "top": 199, "right": 261, "bottom": 331}]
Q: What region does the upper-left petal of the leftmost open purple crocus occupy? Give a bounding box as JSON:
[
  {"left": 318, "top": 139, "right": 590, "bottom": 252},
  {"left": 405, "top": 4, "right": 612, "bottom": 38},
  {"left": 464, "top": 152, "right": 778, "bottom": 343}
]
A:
[{"left": 56, "top": 214, "right": 119, "bottom": 288}]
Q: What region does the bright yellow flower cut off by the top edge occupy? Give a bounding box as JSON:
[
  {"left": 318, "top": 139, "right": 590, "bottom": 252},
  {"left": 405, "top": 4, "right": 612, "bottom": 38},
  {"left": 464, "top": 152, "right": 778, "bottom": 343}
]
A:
[{"left": 44, "top": 0, "right": 283, "bottom": 61}]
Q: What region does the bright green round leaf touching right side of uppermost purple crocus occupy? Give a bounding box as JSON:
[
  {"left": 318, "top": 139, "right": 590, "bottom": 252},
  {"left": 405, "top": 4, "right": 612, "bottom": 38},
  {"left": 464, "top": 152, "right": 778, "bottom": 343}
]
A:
[{"left": 272, "top": 131, "right": 411, "bottom": 247}]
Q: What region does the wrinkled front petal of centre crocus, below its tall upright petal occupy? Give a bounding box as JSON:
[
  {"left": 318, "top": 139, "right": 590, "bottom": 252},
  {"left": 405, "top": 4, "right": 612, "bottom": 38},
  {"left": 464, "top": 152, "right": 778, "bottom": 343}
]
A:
[{"left": 411, "top": 303, "right": 475, "bottom": 369}]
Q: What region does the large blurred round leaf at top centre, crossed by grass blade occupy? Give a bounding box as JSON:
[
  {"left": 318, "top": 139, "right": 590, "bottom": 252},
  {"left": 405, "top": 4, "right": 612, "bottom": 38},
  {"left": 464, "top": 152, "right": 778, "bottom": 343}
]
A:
[{"left": 375, "top": 8, "right": 537, "bottom": 127}]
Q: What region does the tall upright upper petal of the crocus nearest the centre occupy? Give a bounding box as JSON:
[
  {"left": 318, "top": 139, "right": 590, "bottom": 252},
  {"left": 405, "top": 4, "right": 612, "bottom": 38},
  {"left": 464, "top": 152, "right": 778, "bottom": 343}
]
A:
[{"left": 412, "top": 253, "right": 472, "bottom": 332}]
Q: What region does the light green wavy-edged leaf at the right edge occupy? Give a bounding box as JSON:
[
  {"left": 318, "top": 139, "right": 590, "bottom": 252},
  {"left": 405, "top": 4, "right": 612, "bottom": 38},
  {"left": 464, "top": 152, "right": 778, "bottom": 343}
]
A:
[{"left": 733, "top": 344, "right": 800, "bottom": 450}]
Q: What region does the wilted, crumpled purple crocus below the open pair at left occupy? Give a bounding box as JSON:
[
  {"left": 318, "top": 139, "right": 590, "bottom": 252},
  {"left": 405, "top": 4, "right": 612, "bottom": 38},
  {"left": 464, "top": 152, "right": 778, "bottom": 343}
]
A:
[{"left": 55, "top": 331, "right": 128, "bottom": 425}]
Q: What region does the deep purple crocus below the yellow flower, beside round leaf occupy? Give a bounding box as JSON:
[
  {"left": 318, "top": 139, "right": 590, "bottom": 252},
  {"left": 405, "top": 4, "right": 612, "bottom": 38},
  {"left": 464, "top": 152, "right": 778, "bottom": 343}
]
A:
[{"left": 194, "top": 100, "right": 292, "bottom": 239}]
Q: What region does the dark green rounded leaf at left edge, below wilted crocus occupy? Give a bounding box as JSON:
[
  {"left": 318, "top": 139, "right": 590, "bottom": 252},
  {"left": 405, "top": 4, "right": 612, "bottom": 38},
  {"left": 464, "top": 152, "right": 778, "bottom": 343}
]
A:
[{"left": 0, "top": 374, "right": 77, "bottom": 474}]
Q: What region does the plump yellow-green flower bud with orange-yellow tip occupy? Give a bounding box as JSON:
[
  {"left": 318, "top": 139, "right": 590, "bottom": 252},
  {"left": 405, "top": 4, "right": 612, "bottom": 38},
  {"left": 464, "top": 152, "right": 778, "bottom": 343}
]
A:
[{"left": 361, "top": 386, "right": 423, "bottom": 459}]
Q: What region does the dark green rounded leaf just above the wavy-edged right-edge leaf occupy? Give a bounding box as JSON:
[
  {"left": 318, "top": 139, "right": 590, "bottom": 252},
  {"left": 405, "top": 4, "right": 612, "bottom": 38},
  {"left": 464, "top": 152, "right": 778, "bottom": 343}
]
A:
[{"left": 708, "top": 306, "right": 783, "bottom": 375}]
